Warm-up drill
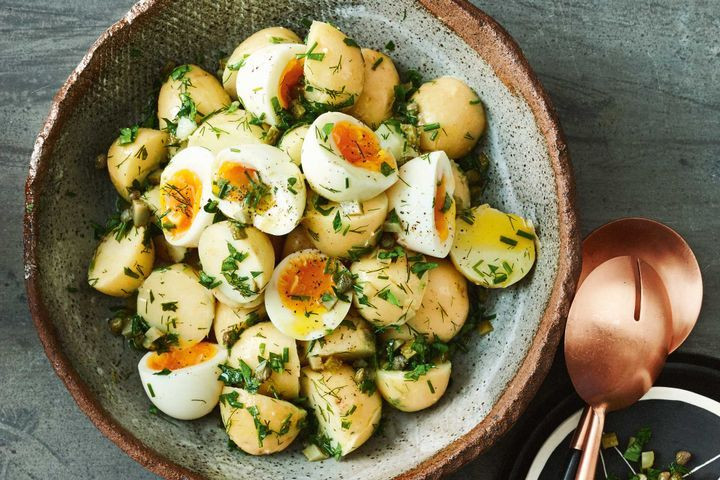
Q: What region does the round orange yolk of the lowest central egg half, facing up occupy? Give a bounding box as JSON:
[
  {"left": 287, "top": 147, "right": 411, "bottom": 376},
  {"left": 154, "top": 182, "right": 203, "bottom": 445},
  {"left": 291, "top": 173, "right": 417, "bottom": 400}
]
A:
[{"left": 278, "top": 256, "right": 335, "bottom": 318}]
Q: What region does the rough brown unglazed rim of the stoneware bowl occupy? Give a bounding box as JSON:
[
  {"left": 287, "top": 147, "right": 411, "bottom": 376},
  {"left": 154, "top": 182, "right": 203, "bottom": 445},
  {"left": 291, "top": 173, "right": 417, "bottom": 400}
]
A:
[{"left": 23, "top": 0, "right": 580, "bottom": 480}]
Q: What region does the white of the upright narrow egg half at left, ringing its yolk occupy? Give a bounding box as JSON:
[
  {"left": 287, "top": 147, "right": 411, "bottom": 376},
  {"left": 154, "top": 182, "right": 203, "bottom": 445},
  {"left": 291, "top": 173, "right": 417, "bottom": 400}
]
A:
[{"left": 159, "top": 147, "right": 214, "bottom": 247}]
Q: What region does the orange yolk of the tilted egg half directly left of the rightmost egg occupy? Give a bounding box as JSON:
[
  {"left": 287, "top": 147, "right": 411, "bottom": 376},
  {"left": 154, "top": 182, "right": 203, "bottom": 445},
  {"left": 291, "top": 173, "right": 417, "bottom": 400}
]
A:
[{"left": 332, "top": 122, "right": 397, "bottom": 175}]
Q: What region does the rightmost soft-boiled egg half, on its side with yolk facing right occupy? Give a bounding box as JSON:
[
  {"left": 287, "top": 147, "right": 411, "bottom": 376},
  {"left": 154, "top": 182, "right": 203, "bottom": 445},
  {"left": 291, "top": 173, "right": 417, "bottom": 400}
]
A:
[{"left": 388, "top": 151, "right": 455, "bottom": 258}]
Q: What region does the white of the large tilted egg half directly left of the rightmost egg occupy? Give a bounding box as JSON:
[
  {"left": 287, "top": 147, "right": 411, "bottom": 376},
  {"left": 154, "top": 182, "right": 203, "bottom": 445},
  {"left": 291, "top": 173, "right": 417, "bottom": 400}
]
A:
[{"left": 301, "top": 112, "right": 398, "bottom": 202}]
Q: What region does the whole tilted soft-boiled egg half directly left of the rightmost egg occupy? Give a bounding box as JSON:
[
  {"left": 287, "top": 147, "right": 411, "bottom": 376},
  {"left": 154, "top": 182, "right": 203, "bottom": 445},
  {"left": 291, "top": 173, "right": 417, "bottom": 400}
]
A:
[{"left": 301, "top": 112, "right": 398, "bottom": 202}]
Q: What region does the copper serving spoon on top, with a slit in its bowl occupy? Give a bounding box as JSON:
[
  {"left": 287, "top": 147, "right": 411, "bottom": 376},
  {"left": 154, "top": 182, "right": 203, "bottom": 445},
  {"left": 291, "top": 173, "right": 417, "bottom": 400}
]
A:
[{"left": 565, "top": 256, "right": 673, "bottom": 480}]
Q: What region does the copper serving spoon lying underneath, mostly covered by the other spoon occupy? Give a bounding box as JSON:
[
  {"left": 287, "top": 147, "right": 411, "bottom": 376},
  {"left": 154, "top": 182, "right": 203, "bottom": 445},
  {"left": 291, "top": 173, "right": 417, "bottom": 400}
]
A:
[{"left": 564, "top": 217, "right": 703, "bottom": 480}]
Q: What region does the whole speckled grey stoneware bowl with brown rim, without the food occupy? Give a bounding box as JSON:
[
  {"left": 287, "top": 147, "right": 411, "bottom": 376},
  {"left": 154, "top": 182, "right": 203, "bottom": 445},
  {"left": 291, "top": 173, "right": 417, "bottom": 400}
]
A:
[{"left": 25, "top": 0, "right": 580, "bottom": 480}]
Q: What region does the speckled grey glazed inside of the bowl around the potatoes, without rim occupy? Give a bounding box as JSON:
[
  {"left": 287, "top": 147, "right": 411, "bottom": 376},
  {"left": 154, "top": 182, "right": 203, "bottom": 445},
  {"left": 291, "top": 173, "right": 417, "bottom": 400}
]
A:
[{"left": 28, "top": 0, "right": 561, "bottom": 480}]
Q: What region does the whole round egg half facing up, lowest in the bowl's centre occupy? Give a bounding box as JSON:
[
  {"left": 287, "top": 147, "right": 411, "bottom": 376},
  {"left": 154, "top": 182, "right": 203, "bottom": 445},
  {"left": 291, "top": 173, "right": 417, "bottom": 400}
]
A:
[{"left": 265, "top": 249, "right": 352, "bottom": 340}]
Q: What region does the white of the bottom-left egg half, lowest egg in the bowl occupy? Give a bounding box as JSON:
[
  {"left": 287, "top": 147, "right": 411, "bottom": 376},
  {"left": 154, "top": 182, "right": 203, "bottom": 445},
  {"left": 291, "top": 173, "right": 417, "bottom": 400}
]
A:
[{"left": 138, "top": 344, "right": 227, "bottom": 420}]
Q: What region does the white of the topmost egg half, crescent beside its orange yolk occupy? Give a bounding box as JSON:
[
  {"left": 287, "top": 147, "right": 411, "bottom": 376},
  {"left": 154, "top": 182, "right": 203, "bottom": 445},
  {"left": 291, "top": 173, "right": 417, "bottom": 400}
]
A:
[{"left": 235, "top": 43, "right": 305, "bottom": 125}]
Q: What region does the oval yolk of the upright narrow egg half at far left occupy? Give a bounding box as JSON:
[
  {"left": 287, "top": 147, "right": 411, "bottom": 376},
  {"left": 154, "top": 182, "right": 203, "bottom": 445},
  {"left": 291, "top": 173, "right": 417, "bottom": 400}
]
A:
[{"left": 160, "top": 170, "right": 202, "bottom": 235}]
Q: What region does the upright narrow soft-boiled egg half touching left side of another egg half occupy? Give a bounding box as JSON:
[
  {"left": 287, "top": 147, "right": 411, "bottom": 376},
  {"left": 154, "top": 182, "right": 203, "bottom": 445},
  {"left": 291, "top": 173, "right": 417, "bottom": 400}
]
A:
[{"left": 158, "top": 147, "right": 214, "bottom": 247}]
